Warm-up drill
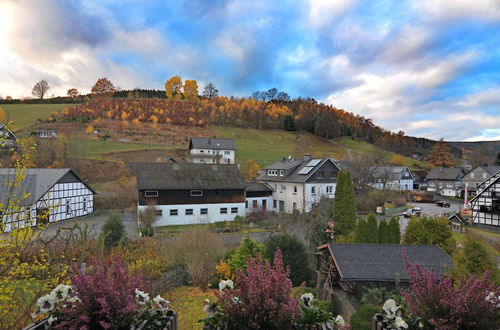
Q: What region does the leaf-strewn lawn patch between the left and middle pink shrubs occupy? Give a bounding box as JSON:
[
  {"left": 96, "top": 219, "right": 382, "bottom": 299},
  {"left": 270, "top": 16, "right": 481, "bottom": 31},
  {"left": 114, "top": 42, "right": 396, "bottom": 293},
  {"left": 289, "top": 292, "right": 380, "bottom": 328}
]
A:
[{"left": 162, "top": 286, "right": 216, "bottom": 329}]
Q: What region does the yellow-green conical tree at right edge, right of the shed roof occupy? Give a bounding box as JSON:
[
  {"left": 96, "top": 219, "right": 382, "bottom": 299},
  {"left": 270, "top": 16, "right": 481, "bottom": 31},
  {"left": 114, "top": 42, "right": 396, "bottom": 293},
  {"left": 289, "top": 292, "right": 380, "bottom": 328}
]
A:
[{"left": 453, "top": 233, "right": 500, "bottom": 283}]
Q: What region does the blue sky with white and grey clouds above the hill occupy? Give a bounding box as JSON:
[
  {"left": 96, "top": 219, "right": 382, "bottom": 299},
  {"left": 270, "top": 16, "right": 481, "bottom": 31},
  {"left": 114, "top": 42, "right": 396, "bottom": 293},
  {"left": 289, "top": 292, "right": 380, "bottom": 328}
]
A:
[{"left": 0, "top": 0, "right": 500, "bottom": 141}]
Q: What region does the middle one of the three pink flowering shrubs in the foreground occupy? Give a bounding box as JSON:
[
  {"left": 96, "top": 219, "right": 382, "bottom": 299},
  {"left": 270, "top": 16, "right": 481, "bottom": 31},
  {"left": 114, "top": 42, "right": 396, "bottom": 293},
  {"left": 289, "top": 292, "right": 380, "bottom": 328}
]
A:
[{"left": 218, "top": 249, "right": 301, "bottom": 330}]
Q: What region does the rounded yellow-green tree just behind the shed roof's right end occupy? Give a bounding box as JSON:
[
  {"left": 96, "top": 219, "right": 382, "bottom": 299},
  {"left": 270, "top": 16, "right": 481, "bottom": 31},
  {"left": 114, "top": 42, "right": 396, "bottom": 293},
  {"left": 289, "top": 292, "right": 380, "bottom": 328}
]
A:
[{"left": 403, "top": 216, "right": 456, "bottom": 255}]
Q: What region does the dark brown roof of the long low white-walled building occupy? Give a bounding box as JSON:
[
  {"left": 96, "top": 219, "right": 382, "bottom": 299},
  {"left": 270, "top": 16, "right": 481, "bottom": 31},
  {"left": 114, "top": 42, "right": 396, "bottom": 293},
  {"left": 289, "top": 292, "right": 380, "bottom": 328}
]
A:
[{"left": 129, "top": 163, "right": 245, "bottom": 190}]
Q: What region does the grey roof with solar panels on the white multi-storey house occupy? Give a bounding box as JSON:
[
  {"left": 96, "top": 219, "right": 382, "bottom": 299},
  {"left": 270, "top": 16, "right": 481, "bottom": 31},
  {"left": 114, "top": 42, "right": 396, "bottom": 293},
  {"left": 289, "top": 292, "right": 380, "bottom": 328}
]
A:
[{"left": 257, "top": 158, "right": 339, "bottom": 182}]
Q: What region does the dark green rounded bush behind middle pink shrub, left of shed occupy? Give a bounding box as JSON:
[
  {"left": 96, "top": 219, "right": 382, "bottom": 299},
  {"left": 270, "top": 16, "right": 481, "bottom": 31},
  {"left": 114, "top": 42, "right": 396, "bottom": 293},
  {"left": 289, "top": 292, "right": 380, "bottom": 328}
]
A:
[{"left": 264, "top": 234, "right": 312, "bottom": 286}]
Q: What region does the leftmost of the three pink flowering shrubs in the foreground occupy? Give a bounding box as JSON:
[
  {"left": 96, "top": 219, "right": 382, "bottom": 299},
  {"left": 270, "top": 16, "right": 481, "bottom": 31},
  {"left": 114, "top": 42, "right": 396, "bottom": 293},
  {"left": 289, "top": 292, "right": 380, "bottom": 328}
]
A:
[{"left": 54, "top": 257, "right": 143, "bottom": 329}]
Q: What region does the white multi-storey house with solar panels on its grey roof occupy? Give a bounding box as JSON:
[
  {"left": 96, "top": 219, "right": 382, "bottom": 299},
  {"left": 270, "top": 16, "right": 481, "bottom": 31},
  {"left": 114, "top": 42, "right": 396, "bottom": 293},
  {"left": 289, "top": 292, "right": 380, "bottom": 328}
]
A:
[{"left": 257, "top": 155, "right": 339, "bottom": 212}]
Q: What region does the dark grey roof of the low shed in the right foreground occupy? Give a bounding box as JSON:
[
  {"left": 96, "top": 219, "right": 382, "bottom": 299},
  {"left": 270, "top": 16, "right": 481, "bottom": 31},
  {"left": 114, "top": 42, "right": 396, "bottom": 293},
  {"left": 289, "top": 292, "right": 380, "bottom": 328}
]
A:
[{"left": 319, "top": 244, "right": 453, "bottom": 282}]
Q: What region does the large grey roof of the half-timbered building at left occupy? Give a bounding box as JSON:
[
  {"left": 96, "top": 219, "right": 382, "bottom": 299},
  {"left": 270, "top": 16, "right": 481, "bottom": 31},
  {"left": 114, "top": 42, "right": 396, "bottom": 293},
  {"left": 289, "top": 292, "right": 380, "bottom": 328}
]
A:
[{"left": 0, "top": 168, "right": 95, "bottom": 205}]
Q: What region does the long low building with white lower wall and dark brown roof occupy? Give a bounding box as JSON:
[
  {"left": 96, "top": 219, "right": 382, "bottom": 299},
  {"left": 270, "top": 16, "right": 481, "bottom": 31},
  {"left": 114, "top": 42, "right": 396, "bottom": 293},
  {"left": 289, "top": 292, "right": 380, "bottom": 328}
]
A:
[{"left": 129, "top": 163, "right": 246, "bottom": 226}]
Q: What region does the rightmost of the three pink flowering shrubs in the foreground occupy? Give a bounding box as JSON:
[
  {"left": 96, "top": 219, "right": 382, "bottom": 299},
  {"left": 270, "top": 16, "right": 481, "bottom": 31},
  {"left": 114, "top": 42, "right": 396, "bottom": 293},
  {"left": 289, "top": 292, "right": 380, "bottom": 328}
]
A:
[{"left": 401, "top": 250, "right": 500, "bottom": 330}]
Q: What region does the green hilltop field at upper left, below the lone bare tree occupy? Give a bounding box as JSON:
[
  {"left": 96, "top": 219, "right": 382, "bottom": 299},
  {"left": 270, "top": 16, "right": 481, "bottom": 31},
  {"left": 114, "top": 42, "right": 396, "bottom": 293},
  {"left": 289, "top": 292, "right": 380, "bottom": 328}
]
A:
[{"left": 0, "top": 104, "right": 74, "bottom": 131}]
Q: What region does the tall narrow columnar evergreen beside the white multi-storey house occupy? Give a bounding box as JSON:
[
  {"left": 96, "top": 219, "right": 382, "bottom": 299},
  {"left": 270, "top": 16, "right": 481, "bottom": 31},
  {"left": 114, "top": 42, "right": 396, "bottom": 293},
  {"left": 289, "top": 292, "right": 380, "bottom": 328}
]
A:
[{"left": 333, "top": 171, "right": 356, "bottom": 236}]
